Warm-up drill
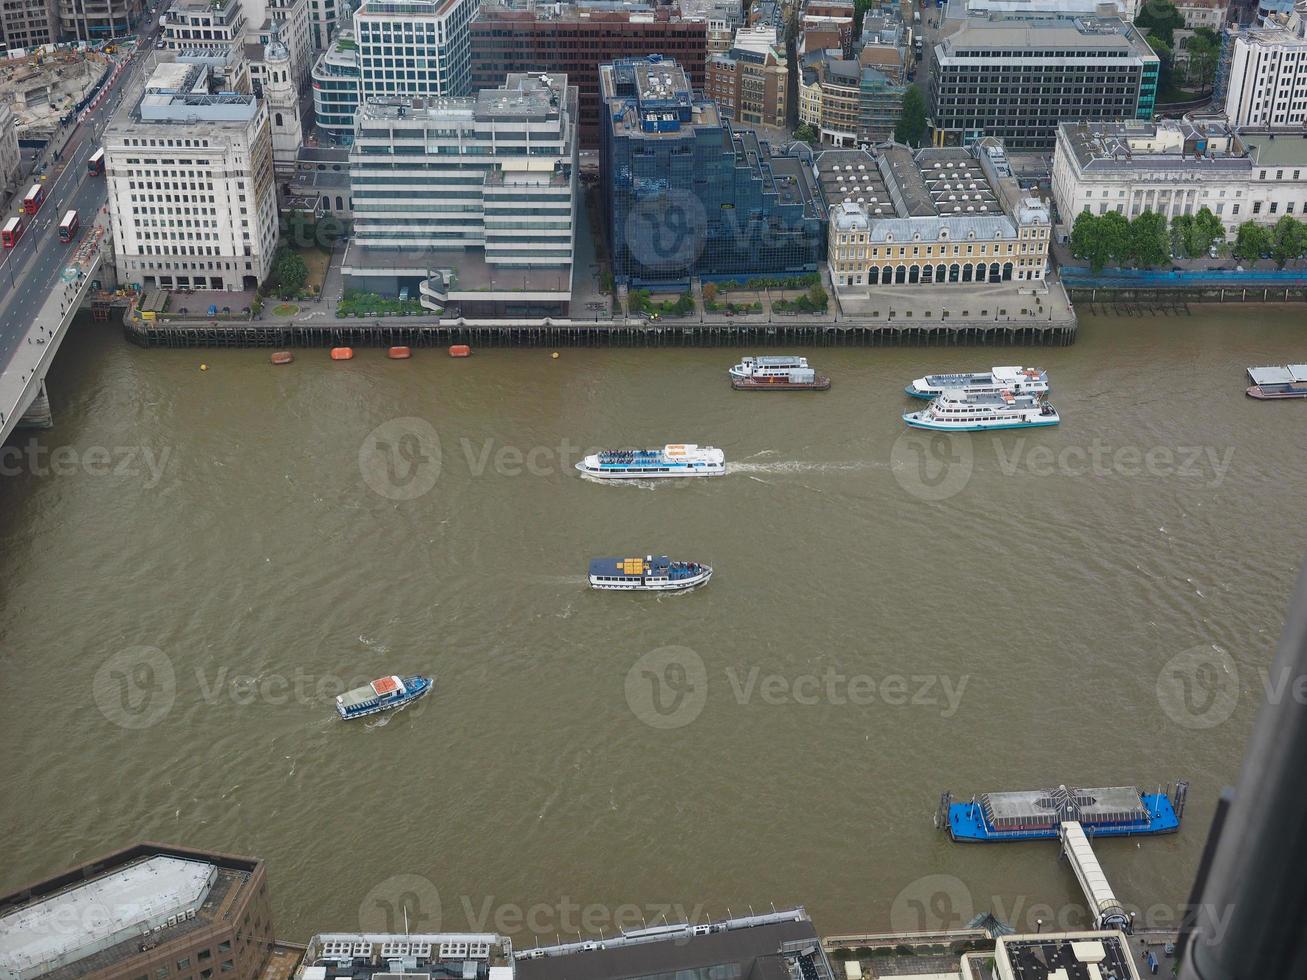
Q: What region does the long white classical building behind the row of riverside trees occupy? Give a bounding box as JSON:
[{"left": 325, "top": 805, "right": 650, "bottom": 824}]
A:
[{"left": 1052, "top": 119, "right": 1307, "bottom": 238}]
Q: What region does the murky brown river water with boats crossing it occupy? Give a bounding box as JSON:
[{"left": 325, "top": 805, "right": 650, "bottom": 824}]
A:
[{"left": 0, "top": 307, "right": 1307, "bottom": 946}]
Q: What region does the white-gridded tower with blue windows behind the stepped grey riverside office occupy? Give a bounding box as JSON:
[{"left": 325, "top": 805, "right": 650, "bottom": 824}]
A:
[{"left": 354, "top": 0, "right": 478, "bottom": 101}]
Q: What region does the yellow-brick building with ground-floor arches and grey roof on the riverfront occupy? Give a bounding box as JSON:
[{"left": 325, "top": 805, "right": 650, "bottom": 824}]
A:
[{"left": 814, "top": 140, "right": 1051, "bottom": 294}]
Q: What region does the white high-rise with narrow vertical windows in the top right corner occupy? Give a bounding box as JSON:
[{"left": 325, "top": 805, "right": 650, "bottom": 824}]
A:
[{"left": 1225, "top": 0, "right": 1307, "bottom": 127}]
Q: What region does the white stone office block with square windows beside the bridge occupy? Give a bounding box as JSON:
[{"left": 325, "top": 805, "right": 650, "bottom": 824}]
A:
[{"left": 105, "top": 61, "right": 277, "bottom": 290}]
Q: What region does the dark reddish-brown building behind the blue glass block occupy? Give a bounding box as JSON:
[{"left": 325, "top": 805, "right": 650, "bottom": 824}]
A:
[{"left": 471, "top": 5, "right": 708, "bottom": 149}]
